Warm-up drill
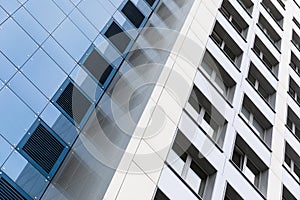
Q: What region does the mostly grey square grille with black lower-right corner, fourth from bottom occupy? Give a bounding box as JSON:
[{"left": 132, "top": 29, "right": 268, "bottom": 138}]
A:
[{"left": 83, "top": 49, "right": 113, "bottom": 85}]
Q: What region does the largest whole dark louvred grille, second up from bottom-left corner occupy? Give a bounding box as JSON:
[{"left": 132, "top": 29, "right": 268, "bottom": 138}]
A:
[{"left": 22, "top": 124, "right": 65, "bottom": 174}]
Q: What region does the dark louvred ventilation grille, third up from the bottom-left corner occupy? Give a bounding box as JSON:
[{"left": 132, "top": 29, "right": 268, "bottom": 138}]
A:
[{"left": 56, "top": 82, "right": 92, "bottom": 124}]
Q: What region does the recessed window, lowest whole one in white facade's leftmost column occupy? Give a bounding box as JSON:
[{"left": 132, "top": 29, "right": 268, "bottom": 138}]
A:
[{"left": 167, "top": 130, "right": 217, "bottom": 200}]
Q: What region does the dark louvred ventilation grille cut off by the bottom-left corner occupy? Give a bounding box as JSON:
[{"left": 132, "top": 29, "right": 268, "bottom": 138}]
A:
[{"left": 0, "top": 177, "right": 26, "bottom": 200}]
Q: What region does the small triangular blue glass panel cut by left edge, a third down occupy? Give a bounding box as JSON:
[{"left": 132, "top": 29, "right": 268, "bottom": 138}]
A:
[{"left": 0, "top": 53, "right": 17, "bottom": 82}]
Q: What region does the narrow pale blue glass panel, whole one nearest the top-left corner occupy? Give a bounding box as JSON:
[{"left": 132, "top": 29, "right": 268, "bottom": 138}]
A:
[{"left": 13, "top": 8, "right": 49, "bottom": 44}]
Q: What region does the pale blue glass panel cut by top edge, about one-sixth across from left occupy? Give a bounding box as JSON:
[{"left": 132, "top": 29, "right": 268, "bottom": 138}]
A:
[{"left": 25, "top": 0, "right": 66, "bottom": 33}]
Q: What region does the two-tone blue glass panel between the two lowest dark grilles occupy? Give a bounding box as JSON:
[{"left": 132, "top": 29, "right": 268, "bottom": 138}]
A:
[{"left": 2, "top": 151, "right": 49, "bottom": 199}]
